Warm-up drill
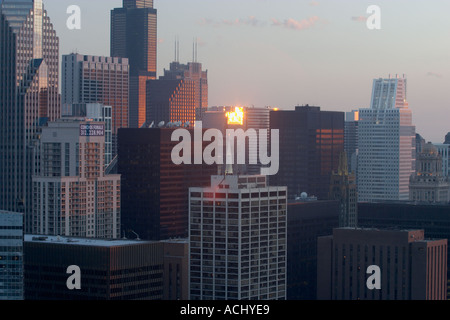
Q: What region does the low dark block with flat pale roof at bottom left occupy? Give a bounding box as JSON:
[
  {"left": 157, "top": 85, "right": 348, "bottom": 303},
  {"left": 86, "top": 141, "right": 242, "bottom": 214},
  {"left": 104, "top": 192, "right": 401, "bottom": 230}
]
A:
[{"left": 24, "top": 234, "right": 164, "bottom": 301}]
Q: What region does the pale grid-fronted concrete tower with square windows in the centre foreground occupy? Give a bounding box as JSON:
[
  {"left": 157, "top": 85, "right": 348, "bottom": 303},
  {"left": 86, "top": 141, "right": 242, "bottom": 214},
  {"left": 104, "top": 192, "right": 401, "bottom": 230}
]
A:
[{"left": 189, "top": 175, "right": 287, "bottom": 300}]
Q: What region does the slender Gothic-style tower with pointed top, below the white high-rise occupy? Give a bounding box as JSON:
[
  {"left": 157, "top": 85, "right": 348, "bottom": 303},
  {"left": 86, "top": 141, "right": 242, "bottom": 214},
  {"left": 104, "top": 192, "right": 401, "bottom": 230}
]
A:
[{"left": 329, "top": 152, "right": 358, "bottom": 228}]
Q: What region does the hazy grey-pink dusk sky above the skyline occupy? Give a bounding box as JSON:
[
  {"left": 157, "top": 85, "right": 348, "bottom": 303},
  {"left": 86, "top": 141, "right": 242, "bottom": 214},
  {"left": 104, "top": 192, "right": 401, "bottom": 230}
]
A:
[{"left": 44, "top": 0, "right": 450, "bottom": 143}]
